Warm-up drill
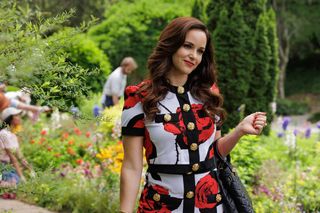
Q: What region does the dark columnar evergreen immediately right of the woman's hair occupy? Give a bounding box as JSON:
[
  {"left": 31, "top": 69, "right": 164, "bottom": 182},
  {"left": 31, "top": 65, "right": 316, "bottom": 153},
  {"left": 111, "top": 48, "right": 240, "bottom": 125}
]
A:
[{"left": 213, "top": 4, "right": 252, "bottom": 132}]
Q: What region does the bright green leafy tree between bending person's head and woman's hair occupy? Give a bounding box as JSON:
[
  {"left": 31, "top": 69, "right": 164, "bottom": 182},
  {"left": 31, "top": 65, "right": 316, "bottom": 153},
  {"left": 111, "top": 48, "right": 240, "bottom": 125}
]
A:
[{"left": 89, "top": 0, "right": 193, "bottom": 83}]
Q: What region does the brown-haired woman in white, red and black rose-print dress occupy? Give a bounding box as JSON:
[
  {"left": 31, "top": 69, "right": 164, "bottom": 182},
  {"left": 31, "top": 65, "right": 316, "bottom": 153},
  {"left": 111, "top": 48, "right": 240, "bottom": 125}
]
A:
[{"left": 120, "top": 17, "right": 266, "bottom": 213}]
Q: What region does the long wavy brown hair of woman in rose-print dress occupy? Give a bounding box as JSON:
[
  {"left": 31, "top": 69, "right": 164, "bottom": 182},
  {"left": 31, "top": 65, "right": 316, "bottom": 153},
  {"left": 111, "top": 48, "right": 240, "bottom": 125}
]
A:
[{"left": 140, "top": 17, "right": 225, "bottom": 120}]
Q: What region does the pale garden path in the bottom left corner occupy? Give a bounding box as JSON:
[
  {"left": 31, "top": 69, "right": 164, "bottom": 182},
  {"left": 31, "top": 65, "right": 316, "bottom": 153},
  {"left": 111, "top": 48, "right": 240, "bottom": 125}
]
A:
[{"left": 0, "top": 199, "right": 53, "bottom": 213}]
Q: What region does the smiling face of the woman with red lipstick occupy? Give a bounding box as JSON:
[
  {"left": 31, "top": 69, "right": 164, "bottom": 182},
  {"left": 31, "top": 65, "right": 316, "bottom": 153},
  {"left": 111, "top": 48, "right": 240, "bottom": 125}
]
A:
[{"left": 170, "top": 29, "right": 207, "bottom": 76}]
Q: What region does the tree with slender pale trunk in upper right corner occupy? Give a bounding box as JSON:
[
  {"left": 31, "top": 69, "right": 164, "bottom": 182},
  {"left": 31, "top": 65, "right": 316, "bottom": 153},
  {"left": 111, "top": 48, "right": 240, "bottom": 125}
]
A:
[{"left": 270, "top": 0, "right": 320, "bottom": 98}]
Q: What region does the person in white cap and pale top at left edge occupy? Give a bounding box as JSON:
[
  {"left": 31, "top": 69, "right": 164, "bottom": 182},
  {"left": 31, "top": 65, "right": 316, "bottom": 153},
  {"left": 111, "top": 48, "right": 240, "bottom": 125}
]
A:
[{"left": 0, "top": 107, "right": 34, "bottom": 186}]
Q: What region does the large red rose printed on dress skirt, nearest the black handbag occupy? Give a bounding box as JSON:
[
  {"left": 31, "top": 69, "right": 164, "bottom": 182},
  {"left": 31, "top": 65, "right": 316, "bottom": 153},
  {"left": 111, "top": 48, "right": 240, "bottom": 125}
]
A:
[{"left": 195, "top": 173, "right": 218, "bottom": 209}]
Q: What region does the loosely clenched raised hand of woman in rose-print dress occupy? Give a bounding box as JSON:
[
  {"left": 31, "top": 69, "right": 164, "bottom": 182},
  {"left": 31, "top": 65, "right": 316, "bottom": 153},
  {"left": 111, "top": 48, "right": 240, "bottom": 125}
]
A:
[{"left": 236, "top": 112, "right": 267, "bottom": 135}]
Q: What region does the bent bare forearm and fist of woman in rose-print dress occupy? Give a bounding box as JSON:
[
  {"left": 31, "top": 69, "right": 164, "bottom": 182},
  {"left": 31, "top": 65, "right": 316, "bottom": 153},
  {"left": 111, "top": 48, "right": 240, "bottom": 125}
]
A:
[{"left": 215, "top": 112, "right": 267, "bottom": 157}]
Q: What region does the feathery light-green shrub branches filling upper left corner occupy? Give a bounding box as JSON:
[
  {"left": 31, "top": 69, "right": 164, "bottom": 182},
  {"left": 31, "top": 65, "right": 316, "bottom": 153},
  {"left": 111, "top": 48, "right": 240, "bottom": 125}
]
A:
[{"left": 0, "top": 1, "right": 90, "bottom": 108}]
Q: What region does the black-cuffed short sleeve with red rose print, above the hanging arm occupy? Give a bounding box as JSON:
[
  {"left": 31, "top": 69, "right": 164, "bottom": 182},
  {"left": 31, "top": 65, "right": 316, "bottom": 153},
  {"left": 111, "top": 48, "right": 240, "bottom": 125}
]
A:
[{"left": 121, "top": 86, "right": 145, "bottom": 136}]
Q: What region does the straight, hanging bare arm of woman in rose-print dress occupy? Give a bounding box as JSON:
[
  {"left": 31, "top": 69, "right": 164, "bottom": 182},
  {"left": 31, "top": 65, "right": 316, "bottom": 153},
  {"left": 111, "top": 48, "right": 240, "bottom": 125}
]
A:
[{"left": 120, "top": 136, "right": 143, "bottom": 213}]
